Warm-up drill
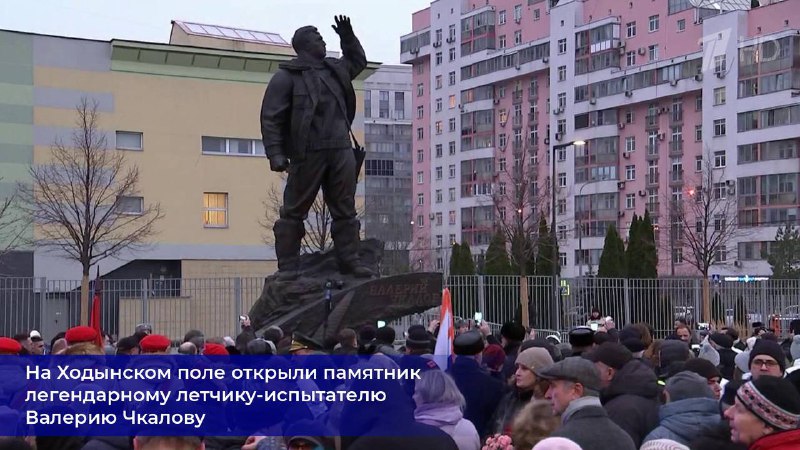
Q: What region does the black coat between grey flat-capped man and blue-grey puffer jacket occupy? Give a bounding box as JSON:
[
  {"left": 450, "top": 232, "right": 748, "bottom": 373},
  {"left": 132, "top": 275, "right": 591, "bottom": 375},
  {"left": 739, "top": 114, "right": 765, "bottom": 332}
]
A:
[{"left": 600, "top": 359, "right": 659, "bottom": 448}]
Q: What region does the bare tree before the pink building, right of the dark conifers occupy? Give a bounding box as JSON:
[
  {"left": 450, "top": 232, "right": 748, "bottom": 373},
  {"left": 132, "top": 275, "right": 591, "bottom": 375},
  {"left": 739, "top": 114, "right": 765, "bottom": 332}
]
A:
[{"left": 669, "top": 152, "right": 747, "bottom": 320}]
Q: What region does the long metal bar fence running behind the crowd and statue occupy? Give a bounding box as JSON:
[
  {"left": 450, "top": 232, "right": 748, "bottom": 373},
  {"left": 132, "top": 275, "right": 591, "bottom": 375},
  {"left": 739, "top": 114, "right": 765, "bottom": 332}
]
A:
[{"left": 0, "top": 276, "right": 800, "bottom": 338}]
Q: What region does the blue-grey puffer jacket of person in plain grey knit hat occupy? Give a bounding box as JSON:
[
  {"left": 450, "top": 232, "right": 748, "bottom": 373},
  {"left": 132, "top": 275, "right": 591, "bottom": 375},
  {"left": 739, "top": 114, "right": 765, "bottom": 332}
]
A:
[{"left": 644, "top": 398, "right": 721, "bottom": 445}]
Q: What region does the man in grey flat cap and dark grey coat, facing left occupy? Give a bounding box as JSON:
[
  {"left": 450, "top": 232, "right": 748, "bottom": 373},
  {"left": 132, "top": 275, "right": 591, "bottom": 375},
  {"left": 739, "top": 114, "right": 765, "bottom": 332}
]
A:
[{"left": 535, "top": 357, "right": 636, "bottom": 450}]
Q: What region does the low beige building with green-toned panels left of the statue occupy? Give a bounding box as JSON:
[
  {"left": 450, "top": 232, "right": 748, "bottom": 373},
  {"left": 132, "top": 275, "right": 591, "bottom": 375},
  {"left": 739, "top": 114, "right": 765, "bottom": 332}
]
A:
[{"left": 0, "top": 22, "right": 377, "bottom": 280}]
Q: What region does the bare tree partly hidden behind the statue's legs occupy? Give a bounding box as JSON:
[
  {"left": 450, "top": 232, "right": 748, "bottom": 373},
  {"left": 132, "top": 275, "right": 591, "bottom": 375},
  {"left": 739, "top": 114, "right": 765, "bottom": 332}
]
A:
[{"left": 258, "top": 175, "right": 363, "bottom": 253}]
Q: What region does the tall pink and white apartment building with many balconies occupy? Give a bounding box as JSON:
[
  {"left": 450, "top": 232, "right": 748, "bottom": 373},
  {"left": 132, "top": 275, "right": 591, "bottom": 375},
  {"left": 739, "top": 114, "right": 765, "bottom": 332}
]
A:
[{"left": 401, "top": 0, "right": 800, "bottom": 277}]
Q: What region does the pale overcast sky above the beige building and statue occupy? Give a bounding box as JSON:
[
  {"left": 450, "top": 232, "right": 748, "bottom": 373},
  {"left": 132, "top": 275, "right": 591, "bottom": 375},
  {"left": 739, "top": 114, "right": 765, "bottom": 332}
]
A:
[{"left": 0, "top": 0, "right": 430, "bottom": 64}]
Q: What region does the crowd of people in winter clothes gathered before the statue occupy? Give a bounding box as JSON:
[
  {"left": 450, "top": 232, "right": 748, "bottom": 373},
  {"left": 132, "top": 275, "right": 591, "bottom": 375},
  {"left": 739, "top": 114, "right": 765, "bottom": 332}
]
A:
[{"left": 0, "top": 310, "right": 800, "bottom": 450}]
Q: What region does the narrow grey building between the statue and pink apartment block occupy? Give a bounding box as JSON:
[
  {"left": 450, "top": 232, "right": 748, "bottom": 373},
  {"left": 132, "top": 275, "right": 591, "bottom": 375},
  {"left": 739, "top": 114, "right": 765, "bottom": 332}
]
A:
[{"left": 362, "top": 65, "right": 412, "bottom": 274}]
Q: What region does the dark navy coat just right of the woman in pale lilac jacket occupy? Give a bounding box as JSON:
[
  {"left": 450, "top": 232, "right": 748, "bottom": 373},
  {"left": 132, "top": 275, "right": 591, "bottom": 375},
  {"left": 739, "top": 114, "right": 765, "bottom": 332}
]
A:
[{"left": 449, "top": 356, "right": 505, "bottom": 437}]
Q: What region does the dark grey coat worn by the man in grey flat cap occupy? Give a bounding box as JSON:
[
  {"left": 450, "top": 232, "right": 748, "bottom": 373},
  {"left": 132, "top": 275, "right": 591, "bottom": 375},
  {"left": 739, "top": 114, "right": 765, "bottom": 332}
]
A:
[{"left": 550, "top": 406, "right": 638, "bottom": 450}]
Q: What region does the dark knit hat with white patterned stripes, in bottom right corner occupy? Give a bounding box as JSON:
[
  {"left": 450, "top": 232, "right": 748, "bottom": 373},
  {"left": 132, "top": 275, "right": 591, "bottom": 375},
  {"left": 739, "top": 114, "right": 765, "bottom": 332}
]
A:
[{"left": 736, "top": 377, "right": 800, "bottom": 431}]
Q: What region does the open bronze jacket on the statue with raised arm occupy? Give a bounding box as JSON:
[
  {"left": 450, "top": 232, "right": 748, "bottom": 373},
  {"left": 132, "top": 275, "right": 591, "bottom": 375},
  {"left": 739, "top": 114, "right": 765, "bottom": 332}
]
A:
[{"left": 261, "top": 36, "right": 367, "bottom": 161}]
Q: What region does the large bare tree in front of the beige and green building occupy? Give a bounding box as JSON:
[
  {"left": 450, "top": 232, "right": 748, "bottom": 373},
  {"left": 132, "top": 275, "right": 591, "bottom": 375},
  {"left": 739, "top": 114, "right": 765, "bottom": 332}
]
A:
[{"left": 18, "top": 98, "right": 164, "bottom": 324}]
